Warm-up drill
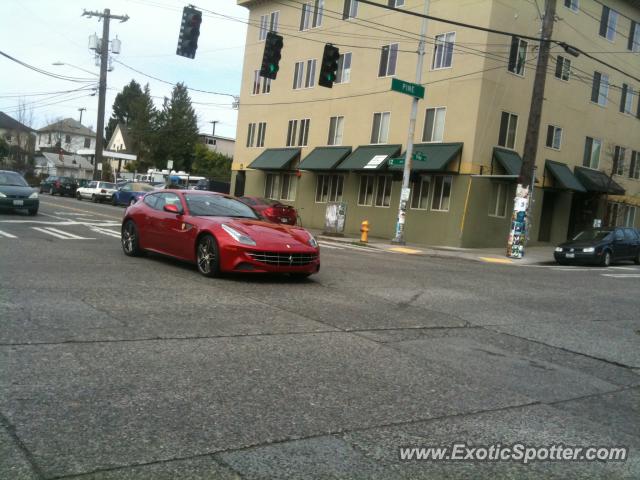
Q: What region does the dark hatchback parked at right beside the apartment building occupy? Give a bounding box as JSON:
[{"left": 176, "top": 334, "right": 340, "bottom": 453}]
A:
[{"left": 553, "top": 227, "right": 640, "bottom": 267}]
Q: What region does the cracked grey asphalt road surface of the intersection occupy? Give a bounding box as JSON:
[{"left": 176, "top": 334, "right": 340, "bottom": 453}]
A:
[{"left": 0, "top": 195, "right": 640, "bottom": 479}]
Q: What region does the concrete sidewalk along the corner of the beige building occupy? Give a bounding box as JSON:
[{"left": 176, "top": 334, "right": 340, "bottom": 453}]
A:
[{"left": 311, "top": 230, "right": 555, "bottom": 265}]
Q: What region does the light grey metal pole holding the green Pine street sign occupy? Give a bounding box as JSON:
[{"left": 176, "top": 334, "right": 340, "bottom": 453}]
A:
[{"left": 392, "top": 0, "right": 430, "bottom": 245}]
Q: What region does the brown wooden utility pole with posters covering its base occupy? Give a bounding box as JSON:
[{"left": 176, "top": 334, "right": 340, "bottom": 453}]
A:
[{"left": 507, "top": 0, "right": 556, "bottom": 258}]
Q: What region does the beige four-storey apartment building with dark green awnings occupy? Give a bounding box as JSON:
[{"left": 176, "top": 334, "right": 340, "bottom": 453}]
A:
[{"left": 232, "top": 0, "right": 640, "bottom": 247}]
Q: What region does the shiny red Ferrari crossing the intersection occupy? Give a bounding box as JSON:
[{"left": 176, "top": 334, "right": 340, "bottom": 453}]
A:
[{"left": 121, "top": 190, "right": 320, "bottom": 278}]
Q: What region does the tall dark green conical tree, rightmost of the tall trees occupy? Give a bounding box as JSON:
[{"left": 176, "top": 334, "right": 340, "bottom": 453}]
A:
[{"left": 152, "top": 83, "right": 198, "bottom": 171}]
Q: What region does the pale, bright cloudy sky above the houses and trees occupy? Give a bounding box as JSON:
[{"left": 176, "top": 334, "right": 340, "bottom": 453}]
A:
[{"left": 0, "top": 0, "right": 248, "bottom": 138}]
